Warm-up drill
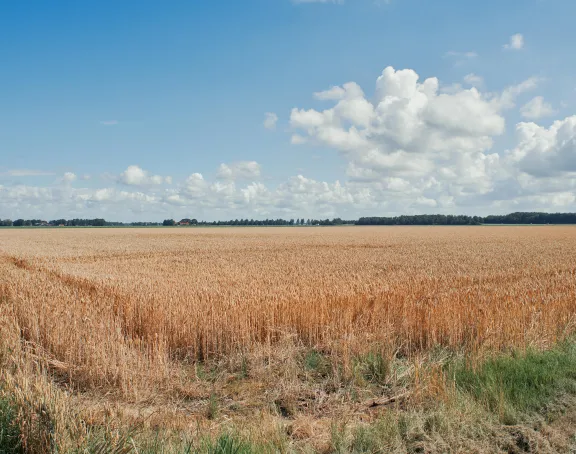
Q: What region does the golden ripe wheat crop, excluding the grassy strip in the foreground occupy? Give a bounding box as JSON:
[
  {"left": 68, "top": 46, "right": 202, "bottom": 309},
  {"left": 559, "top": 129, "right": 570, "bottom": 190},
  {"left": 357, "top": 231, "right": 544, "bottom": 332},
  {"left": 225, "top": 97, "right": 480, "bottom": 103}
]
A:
[{"left": 0, "top": 226, "right": 576, "bottom": 450}]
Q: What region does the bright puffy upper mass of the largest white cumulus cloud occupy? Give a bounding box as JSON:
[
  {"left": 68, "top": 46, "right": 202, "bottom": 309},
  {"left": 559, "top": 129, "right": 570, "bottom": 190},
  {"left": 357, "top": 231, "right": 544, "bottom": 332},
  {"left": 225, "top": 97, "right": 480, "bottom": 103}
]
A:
[{"left": 290, "top": 67, "right": 514, "bottom": 164}]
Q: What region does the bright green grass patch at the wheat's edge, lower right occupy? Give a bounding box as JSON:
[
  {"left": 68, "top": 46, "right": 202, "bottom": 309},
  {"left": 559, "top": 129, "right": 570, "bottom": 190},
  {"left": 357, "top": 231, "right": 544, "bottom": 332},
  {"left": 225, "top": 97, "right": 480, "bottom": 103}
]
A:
[{"left": 449, "top": 343, "right": 576, "bottom": 422}]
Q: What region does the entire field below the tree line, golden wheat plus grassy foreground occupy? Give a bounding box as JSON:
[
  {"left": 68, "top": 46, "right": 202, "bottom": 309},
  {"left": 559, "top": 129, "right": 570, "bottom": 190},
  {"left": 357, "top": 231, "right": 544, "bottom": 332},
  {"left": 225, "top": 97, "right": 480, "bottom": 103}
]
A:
[{"left": 0, "top": 226, "right": 576, "bottom": 453}]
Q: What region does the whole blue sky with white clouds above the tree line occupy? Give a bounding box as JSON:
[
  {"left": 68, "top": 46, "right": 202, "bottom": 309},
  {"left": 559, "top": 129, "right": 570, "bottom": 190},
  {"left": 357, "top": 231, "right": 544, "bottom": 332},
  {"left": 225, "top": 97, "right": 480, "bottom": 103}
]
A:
[{"left": 0, "top": 0, "right": 576, "bottom": 221}]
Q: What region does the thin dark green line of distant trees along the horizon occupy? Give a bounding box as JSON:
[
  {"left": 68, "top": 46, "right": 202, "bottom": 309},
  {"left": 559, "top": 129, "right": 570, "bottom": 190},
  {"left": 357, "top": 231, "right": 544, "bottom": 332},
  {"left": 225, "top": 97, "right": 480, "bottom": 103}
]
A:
[{"left": 0, "top": 212, "right": 576, "bottom": 227}]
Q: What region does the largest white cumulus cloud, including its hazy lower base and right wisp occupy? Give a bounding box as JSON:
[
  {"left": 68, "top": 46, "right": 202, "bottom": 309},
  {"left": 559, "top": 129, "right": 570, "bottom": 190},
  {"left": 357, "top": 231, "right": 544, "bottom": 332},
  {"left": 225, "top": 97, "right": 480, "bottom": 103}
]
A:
[{"left": 290, "top": 67, "right": 565, "bottom": 209}]
